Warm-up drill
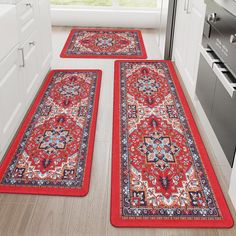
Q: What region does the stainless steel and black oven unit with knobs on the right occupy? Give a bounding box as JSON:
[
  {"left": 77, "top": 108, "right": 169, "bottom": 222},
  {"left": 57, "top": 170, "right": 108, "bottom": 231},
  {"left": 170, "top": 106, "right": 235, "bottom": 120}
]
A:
[{"left": 196, "top": 0, "right": 236, "bottom": 167}]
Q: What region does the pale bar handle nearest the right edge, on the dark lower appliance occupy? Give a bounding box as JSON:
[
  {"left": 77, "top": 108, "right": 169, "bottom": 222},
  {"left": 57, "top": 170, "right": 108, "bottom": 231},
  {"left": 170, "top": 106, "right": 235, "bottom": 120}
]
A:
[{"left": 213, "top": 64, "right": 236, "bottom": 97}]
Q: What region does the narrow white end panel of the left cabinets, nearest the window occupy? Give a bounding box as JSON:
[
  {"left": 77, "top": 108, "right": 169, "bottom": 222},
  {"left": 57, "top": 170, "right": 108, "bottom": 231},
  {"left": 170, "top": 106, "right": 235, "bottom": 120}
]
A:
[{"left": 38, "top": 0, "right": 52, "bottom": 72}]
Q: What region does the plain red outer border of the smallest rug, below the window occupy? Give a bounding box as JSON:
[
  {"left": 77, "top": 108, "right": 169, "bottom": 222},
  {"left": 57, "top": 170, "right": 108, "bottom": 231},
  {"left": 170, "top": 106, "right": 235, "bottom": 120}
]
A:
[{"left": 60, "top": 28, "right": 147, "bottom": 59}]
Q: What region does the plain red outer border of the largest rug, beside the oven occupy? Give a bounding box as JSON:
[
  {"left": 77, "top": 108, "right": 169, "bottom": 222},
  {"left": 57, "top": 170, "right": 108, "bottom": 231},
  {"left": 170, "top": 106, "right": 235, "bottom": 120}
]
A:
[{"left": 110, "top": 60, "right": 234, "bottom": 228}]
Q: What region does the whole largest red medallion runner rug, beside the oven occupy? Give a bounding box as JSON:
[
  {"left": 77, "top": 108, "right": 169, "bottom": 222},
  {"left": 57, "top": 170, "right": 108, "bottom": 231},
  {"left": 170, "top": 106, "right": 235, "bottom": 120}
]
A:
[{"left": 111, "top": 61, "right": 233, "bottom": 228}]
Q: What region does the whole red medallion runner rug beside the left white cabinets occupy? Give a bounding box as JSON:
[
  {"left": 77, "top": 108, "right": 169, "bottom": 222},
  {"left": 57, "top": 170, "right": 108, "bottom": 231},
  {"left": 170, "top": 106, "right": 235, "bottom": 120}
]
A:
[{"left": 0, "top": 70, "right": 101, "bottom": 196}]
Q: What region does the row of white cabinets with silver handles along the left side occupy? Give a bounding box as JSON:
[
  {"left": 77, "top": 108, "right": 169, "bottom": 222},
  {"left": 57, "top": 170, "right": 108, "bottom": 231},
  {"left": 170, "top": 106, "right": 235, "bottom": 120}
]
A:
[{"left": 0, "top": 0, "right": 52, "bottom": 159}]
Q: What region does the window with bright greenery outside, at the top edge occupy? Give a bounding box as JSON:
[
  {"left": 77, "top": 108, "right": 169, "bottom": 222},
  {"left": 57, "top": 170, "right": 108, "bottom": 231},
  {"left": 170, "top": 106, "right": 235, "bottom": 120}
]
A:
[{"left": 50, "top": 0, "right": 159, "bottom": 8}]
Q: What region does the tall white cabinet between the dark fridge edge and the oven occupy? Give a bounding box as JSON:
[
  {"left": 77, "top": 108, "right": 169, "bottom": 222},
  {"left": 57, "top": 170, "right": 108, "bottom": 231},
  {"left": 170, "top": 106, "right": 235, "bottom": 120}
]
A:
[{"left": 173, "top": 0, "right": 206, "bottom": 98}]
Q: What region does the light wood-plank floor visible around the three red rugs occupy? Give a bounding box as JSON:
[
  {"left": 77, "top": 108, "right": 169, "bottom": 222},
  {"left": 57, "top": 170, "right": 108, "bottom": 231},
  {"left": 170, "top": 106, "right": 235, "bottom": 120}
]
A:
[{"left": 0, "top": 28, "right": 236, "bottom": 236}]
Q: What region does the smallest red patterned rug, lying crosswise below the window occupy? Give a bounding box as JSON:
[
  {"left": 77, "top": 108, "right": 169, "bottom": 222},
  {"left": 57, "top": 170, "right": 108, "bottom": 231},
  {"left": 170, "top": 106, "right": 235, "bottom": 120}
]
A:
[{"left": 61, "top": 29, "right": 147, "bottom": 59}]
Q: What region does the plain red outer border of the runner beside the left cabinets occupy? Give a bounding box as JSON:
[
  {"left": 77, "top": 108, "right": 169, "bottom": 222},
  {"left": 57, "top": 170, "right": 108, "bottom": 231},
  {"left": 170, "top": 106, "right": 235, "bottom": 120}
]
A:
[{"left": 0, "top": 69, "right": 102, "bottom": 197}]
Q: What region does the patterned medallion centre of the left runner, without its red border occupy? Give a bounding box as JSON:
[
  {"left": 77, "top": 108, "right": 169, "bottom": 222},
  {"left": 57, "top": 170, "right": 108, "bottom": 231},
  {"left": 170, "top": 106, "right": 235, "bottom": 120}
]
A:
[{"left": 1, "top": 71, "right": 98, "bottom": 188}]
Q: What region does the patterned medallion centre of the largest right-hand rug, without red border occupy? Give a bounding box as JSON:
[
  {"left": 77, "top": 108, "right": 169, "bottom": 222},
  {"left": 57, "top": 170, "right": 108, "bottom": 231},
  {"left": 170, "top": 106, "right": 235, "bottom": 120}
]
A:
[{"left": 119, "top": 61, "right": 222, "bottom": 219}]
